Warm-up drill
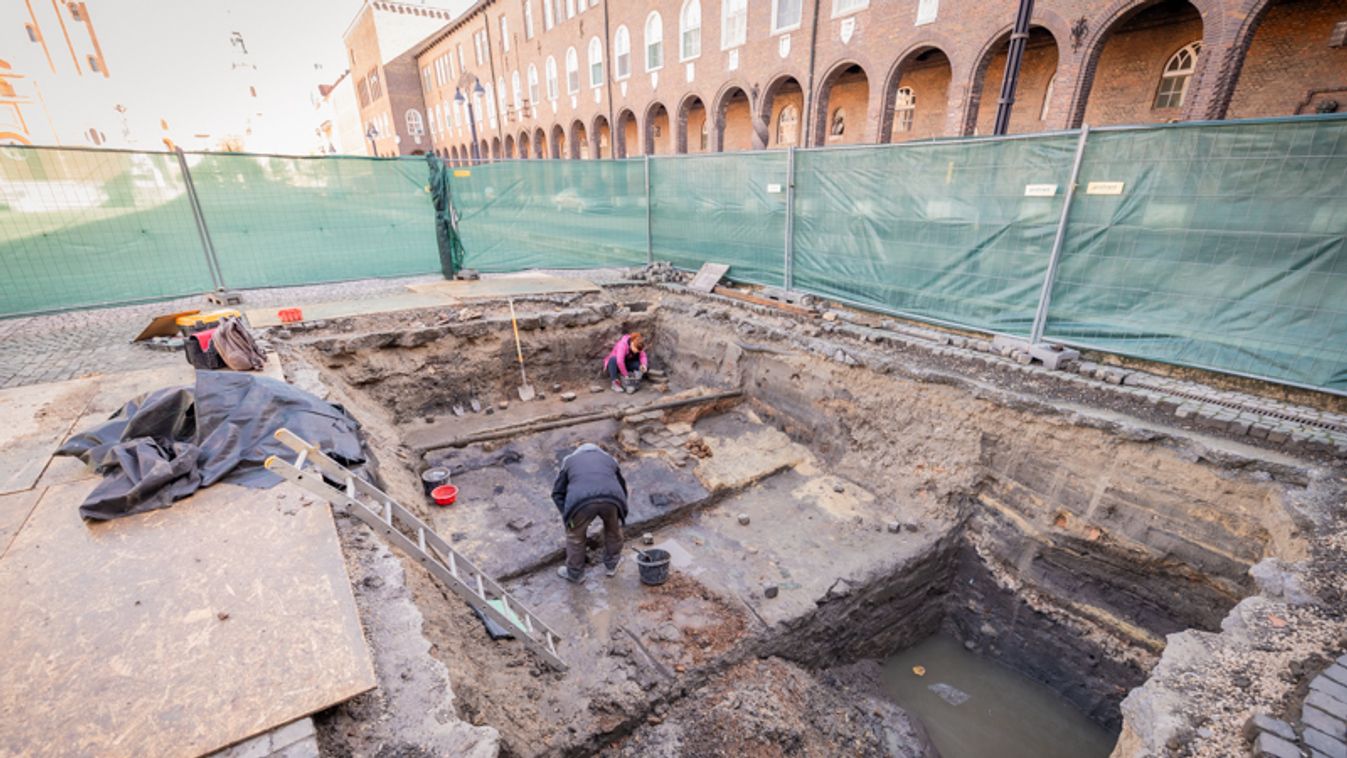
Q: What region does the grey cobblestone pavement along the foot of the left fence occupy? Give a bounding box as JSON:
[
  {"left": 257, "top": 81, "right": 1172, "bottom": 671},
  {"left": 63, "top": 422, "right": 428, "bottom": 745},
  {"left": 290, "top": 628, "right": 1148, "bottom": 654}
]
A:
[{"left": 0, "top": 275, "right": 440, "bottom": 389}]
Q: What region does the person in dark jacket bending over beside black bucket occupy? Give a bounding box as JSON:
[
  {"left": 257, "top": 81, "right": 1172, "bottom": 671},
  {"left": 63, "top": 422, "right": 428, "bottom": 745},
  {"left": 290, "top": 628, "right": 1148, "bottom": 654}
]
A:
[{"left": 552, "top": 443, "right": 626, "bottom": 583}]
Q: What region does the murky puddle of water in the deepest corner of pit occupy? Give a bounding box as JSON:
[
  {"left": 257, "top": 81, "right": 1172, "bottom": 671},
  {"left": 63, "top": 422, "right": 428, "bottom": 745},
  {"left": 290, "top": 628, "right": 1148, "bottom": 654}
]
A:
[{"left": 884, "top": 637, "right": 1117, "bottom": 758}]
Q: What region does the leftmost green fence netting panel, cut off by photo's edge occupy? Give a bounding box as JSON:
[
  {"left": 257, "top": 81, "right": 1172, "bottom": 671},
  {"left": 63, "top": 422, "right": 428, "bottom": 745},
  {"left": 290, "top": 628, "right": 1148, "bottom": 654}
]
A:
[{"left": 0, "top": 147, "right": 211, "bottom": 315}]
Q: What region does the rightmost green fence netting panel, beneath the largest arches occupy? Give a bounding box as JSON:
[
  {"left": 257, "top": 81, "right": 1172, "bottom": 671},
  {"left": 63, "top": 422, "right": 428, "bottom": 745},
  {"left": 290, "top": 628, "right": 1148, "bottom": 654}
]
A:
[{"left": 1047, "top": 118, "right": 1347, "bottom": 390}]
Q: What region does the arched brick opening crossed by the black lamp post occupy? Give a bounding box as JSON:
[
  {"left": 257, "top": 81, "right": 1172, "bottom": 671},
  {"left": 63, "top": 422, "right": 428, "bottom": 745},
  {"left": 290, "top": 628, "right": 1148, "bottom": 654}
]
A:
[{"left": 963, "top": 27, "right": 1057, "bottom": 135}]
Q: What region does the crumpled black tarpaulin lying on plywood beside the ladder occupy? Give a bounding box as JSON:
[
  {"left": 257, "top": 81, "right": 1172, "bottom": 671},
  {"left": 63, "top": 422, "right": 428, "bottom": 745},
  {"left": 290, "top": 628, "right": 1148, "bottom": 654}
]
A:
[{"left": 57, "top": 370, "right": 365, "bottom": 521}]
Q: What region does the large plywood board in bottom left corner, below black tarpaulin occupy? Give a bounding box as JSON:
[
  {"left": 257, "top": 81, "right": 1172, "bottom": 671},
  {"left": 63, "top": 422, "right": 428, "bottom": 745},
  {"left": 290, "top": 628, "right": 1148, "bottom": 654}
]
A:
[{"left": 0, "top": 479, "right": 374, "bottom": 755}]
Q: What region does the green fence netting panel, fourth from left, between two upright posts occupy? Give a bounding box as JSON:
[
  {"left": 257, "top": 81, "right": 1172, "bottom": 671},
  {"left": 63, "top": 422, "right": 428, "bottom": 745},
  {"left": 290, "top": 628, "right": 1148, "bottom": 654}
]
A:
[{"left": 651, "top": 151, "right": 789, "bottom": 287}]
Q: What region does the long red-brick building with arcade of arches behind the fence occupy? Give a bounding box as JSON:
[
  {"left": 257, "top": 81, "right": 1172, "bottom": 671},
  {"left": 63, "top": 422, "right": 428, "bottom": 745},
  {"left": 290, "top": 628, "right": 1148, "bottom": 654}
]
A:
[{"left": 404, "top": 0, "right": 1347, "bottom": 162}]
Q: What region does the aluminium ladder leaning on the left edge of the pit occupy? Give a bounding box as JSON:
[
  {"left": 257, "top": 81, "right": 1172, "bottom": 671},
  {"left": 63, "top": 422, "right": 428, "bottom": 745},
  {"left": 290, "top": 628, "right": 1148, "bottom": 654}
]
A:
[{"left": 267, "top": 429, "right": 567, "bottom": 670}]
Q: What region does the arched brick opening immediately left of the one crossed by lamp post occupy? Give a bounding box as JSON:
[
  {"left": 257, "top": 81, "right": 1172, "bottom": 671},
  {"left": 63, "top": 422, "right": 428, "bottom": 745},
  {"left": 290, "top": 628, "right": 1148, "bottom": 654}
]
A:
[{"left": 880, "top": 47, "right": 954, "bottom": 143}]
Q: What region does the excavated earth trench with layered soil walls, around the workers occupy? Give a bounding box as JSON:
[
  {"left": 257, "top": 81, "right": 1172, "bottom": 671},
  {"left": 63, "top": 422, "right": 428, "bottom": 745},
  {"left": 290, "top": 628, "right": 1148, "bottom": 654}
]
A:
[{"left": 288, "top": 288, "right": 1297, "bottom": 755}]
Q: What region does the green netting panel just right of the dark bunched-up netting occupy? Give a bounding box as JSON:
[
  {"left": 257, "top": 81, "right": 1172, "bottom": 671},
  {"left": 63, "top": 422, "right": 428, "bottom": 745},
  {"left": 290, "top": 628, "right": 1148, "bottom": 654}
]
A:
[{"left": 450, "top": 160, "right": 645, "bottom": 272}]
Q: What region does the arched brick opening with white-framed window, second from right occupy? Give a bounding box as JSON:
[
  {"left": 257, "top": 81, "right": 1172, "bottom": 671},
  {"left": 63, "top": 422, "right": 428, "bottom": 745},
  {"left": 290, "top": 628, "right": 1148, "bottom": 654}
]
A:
[{"left": 1083, "top": 0, "right": 1202, "bottom": 127}]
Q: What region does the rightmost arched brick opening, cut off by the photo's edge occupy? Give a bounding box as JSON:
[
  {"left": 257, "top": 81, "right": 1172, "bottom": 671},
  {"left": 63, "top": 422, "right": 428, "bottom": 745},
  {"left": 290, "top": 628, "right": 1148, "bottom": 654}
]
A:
[{"left": 1227, "top": 0, "right": 1347, "bottom": 118}]
